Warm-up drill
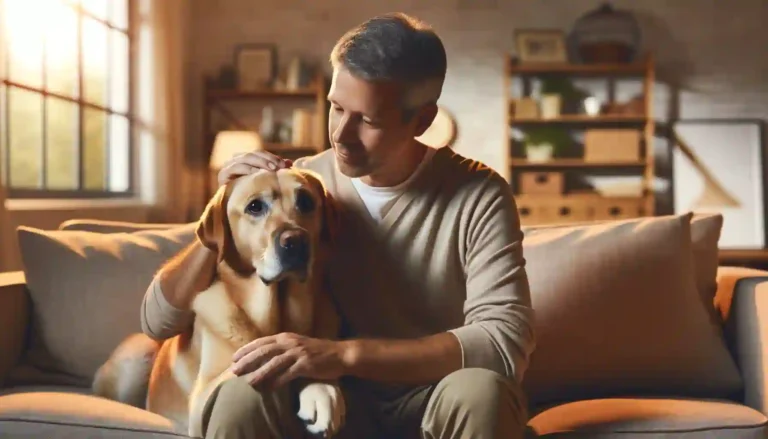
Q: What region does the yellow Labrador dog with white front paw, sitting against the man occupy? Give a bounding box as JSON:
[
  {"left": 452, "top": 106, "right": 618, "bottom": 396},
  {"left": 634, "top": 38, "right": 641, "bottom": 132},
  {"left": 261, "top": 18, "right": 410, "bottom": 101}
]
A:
[{"left": 93, "top": 168, "right": 346, "bottom": 437}]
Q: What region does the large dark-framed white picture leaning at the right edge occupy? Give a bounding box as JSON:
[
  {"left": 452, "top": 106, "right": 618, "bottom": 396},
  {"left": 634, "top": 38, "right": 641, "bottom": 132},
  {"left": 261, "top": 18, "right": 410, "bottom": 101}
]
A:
[{"left": 672, "top": 119, "right": 768, "bottom": 249}]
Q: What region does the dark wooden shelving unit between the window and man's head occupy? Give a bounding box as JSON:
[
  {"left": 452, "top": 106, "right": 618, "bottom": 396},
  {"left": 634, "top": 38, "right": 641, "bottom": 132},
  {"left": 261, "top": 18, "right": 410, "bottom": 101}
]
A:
[{"left": 202, "top": 72, "right": 328, "bottom": 165}]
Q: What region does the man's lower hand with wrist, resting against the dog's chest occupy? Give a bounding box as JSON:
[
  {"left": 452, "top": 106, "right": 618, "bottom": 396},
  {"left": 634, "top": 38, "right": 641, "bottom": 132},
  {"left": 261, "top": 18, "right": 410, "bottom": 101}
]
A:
[{"left": 232, "top": 333, "right": 347, "bottom": 388}]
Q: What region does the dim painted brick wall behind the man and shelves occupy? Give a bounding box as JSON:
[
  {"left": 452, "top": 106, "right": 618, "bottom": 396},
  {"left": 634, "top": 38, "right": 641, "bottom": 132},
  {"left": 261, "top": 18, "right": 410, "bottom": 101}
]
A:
[{"left": 188, "top": 0, "right": 768, "bottom": 212}]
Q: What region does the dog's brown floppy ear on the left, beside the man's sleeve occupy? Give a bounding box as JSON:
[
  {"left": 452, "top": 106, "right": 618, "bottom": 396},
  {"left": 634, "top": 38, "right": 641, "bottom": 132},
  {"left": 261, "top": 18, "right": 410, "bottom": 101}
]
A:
[{"left": 196, "top": 182, "right": 254, "bottom": 276}]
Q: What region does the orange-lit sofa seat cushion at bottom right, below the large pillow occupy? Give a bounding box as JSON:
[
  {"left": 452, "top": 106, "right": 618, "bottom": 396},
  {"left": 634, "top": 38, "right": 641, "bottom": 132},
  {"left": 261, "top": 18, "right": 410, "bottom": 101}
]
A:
[{"left": 528, "top": 398, "right": 768, "bottom": 439}]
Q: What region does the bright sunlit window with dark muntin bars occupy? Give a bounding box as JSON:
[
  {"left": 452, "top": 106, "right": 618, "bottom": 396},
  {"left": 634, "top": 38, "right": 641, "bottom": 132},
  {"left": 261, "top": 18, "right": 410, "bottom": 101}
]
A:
[{"left": 0, "top": 0, "right": 133, "bottom": 198}]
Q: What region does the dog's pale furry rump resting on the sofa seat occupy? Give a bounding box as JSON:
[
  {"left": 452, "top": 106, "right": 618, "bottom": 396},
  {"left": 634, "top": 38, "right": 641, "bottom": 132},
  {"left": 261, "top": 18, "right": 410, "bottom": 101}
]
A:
[{"left": 91, "top": 334, "right": 160, "bottom": 409}]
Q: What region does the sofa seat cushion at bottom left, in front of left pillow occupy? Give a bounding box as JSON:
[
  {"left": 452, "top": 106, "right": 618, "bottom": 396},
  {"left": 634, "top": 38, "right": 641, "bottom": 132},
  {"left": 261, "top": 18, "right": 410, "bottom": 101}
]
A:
[{"left": 0, "top": 387, "right": 188, "bottom": 439}]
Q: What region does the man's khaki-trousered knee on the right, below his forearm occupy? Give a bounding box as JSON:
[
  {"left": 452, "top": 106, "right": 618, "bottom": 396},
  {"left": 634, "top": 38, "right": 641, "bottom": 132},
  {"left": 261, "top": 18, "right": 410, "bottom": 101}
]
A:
[{"left": 422, "top": 369, "right": 528, "bottom": 438}]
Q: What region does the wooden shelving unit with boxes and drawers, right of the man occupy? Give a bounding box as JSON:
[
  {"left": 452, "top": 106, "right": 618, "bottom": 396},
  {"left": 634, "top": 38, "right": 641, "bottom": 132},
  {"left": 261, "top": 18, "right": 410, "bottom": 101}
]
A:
[{"left": 505, "top": 52, "right": 655, "bottom": 224}]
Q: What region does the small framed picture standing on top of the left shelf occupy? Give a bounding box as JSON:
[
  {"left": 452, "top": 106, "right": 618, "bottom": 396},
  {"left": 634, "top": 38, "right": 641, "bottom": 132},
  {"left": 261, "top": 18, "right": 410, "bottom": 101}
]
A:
[{"left": 234, "top": 43, "right": 277, "bottom": 91}]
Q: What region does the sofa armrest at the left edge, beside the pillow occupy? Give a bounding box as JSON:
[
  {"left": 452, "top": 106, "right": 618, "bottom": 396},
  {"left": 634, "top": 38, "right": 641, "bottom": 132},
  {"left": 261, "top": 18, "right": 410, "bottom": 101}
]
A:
[{"left": 0, "top": 271, "right": 30, "bottom": 388}]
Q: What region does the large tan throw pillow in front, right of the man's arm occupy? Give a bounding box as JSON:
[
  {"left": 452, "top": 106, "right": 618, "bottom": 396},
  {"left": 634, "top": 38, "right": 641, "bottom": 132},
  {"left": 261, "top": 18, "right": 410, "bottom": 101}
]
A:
[{"left": 523, "top": 214, "right": 741, "bottom": 404}]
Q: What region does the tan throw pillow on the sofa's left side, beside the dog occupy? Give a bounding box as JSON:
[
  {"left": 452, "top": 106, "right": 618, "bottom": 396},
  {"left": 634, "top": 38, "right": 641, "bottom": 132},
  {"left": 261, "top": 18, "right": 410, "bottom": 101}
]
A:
[{"left": 17, "top": 224, "right": 194, "bottom": 385}]
